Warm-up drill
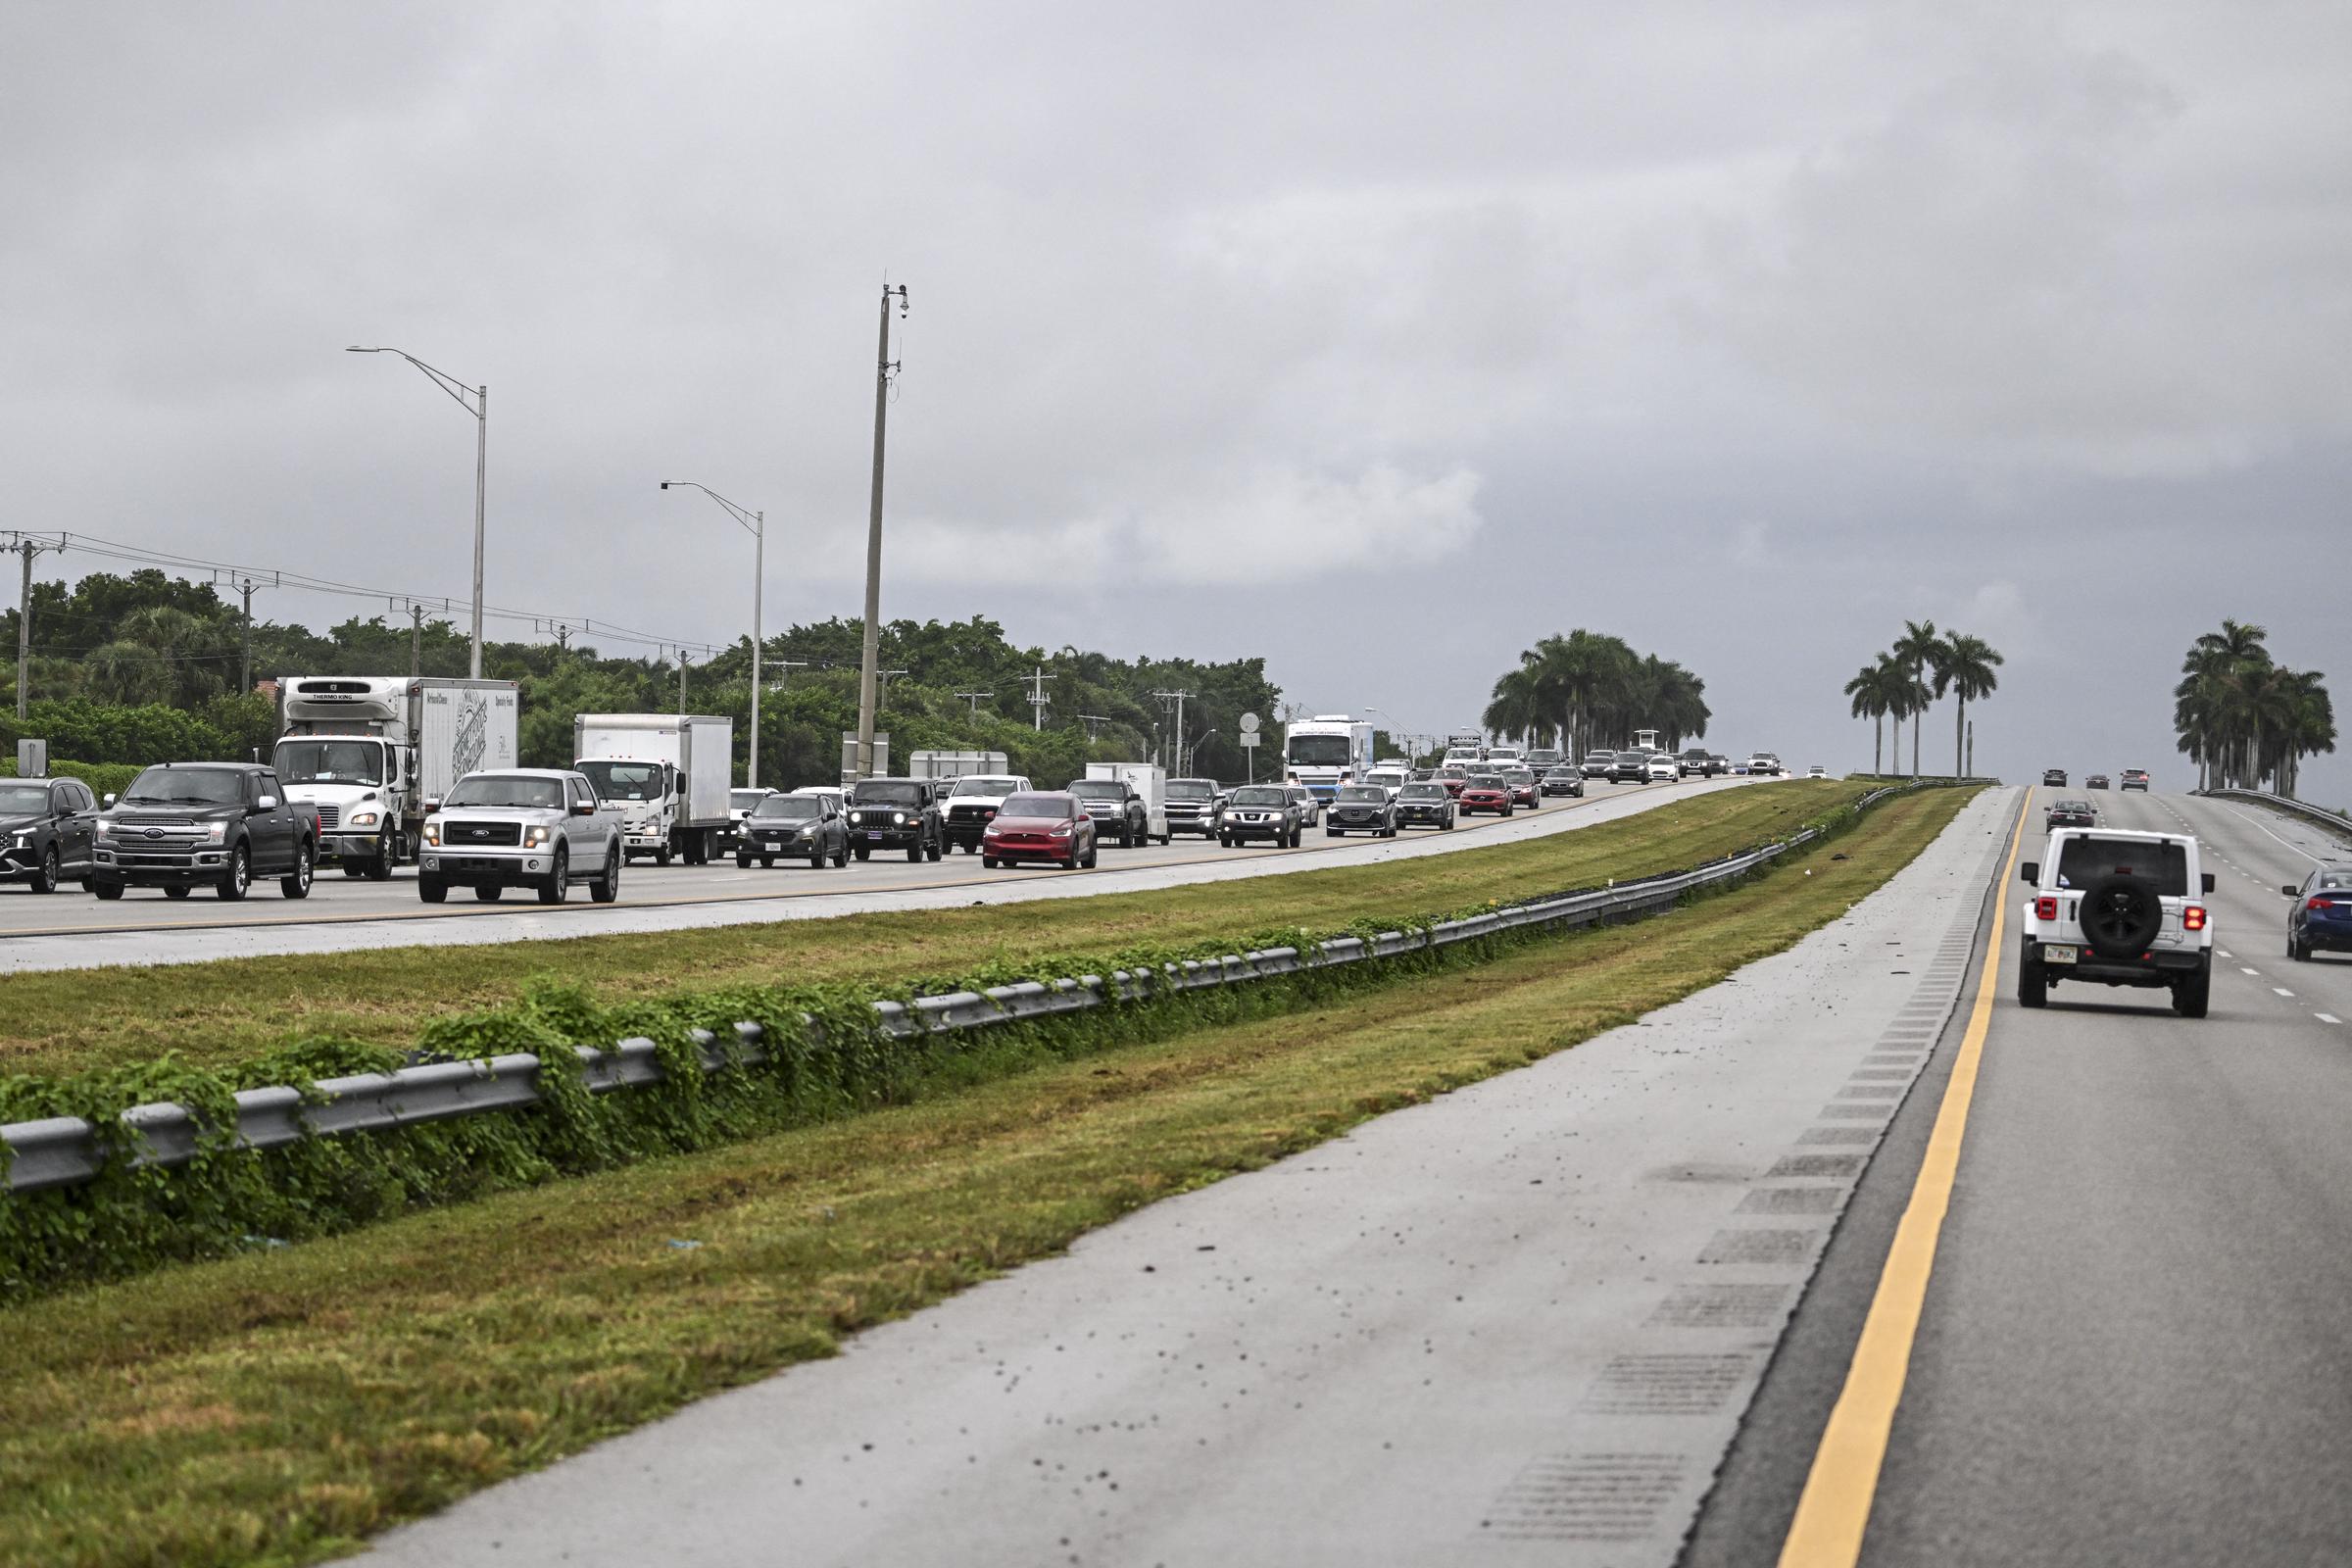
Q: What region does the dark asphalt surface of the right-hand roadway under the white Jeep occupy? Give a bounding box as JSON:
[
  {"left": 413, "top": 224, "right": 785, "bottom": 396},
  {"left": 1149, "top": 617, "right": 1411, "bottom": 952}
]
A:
[{"left": 1687, "top": 790, "right": 2352, "bottom": 1568}]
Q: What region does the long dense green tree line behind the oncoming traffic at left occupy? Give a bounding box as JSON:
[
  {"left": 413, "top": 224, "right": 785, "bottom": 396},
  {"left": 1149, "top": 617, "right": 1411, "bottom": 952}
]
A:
[{"left": 0, "top": 569, "right": 1282, "bottom": 785}]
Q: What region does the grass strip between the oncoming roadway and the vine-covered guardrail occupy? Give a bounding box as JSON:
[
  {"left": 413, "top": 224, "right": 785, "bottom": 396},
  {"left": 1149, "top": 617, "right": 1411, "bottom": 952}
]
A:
[{"left": 0, "top": 780, "right": 1868, "bottom": 1074}]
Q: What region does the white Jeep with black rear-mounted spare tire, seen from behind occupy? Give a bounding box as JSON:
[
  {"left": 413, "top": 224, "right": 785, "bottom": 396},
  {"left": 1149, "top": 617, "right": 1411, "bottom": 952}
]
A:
[{"left": 2018, "top": 827, "right": 2213, "bottom": 1018}]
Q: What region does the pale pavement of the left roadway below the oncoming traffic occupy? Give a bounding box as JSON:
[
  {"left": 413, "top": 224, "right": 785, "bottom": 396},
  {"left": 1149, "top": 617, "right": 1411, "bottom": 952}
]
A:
[{"left": 0, "top": 778, "right": 1750, "bottom": 973}]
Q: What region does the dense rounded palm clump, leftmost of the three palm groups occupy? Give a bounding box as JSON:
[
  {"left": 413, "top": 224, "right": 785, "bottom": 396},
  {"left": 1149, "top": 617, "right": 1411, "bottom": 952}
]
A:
[{"left": 1480, "top": 627, "right": 1712, "bottom": 757}]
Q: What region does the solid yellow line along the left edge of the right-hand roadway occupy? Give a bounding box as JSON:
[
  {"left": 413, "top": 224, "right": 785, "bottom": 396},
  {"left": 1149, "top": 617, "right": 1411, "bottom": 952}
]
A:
[{"left": 1781, "top": 790, "right": 2034, "bottom": 1568}]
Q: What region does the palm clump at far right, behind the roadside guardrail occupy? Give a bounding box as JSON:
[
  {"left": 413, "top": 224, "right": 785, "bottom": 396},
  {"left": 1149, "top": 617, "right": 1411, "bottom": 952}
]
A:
[{"left": 2174, "top": 620, "right": 2335, "bottom": 795}]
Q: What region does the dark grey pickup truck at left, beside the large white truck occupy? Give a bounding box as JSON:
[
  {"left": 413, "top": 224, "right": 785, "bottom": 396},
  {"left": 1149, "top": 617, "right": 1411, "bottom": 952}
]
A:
[{"left": 89, "top": 761, "right": 318, "bottom": 901}]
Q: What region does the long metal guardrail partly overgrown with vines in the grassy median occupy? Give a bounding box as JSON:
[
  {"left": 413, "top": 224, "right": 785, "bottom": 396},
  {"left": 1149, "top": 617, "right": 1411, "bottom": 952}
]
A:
[{"left": 0, "top": 788, "right": 1898, "bottom": 1192}]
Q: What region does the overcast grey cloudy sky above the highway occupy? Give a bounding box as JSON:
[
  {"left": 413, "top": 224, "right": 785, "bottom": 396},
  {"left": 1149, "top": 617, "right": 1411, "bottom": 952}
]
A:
[{"left": 0, "top": 0, "right": 2352, "bottom": 800}]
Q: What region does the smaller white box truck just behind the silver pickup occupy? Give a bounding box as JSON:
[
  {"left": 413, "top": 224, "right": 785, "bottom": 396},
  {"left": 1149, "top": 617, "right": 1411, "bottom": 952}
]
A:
[{"left": 571, "top": 712, "right": 734, "bottom": 865}]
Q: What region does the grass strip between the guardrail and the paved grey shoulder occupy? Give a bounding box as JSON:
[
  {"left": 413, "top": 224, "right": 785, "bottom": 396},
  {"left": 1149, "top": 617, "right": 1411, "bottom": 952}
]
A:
[{"left": 0, "top": 790, "right": 1966, "bottom": 1568}]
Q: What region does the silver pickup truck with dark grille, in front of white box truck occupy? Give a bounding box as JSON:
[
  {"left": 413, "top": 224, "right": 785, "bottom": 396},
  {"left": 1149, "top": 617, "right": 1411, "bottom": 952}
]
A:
[{"left": 416, "top": 768, "right": 625, "bottom": 903}]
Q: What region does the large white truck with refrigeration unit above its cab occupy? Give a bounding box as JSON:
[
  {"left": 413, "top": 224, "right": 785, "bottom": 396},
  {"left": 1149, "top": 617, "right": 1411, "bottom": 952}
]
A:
[{"left": 270, "top": 674, "right": 522, "bottom": 882}]
